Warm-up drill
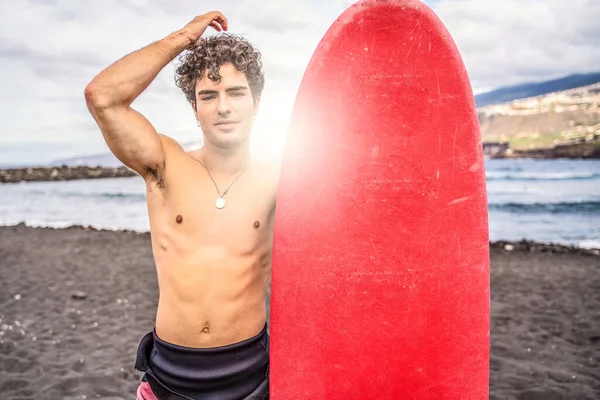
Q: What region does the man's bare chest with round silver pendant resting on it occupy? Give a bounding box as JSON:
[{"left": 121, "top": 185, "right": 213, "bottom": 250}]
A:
[{"left": 149, "top": 171, "right": 276, "bottom": 253}]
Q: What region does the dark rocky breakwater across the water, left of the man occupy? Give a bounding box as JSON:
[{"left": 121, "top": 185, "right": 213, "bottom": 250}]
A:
[{"left": 0, "top": 165, "right": 137, "bottom": 183}]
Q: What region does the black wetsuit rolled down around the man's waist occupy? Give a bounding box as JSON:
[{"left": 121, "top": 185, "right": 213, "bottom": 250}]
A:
[{"left": 135, "top": 323, "right": 269, "bottom": 400}]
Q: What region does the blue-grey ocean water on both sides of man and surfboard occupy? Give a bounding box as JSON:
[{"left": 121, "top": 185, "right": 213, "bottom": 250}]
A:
[{"left": 0, "top": 160, "right": 600, "bottom": 248}]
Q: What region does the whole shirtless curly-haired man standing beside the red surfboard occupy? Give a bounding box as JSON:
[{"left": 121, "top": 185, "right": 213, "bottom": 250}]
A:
[{"left": 85, "top": 11, "right": 279, "bottom": 400}]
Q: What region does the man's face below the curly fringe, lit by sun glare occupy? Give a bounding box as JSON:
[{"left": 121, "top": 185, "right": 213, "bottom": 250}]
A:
[{"left": 195, "top": 64, "right": 258, "bottom": 147}]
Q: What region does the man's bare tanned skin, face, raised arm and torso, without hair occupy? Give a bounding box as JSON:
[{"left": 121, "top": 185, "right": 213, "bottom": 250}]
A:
[{"left": 85, "top": 11, "right": 279, "bottom": 348}]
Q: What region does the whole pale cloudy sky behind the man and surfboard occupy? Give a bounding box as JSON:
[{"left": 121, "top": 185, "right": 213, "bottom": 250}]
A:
[{"left": 0, "top": 0, "right": 600, "bottom": 165}]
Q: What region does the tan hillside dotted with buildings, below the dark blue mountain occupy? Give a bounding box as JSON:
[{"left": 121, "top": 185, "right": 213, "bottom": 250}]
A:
[{"left": 478, "top": 83, "right": 600, "bottom": 158}]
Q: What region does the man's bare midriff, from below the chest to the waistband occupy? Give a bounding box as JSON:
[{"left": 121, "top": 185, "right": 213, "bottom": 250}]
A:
[{"left": 155, "top": 241, "right": 268, "bottom": 348}]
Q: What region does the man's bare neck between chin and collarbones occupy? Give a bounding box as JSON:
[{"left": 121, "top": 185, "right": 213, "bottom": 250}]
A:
[{"left": 200, "top": 143, "right": 250, "bottom": 175}]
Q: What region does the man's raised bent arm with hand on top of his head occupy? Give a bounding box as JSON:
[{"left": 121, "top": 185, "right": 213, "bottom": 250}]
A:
[{"left": 84, "top": 11, "right": 227, "bottom": 181}]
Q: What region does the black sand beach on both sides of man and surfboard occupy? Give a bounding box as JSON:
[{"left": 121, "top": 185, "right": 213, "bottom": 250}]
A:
[{"left": 0, "top": 225, "right": 600, "bottom": 400}]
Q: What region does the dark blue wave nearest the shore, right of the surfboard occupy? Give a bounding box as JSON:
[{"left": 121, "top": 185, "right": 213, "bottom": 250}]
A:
[{"left": 488, "top": 201, "right": 600, "bottom": 214}]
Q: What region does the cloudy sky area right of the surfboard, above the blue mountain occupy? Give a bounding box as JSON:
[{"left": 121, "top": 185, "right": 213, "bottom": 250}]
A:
[{"left": 434, "top": 0, "right": 600, "bottom": 88}]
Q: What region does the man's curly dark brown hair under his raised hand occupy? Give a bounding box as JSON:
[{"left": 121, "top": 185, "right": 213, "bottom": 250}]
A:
[{"left": 175, "top": 33, "right": 265, "bottom": 105}]
